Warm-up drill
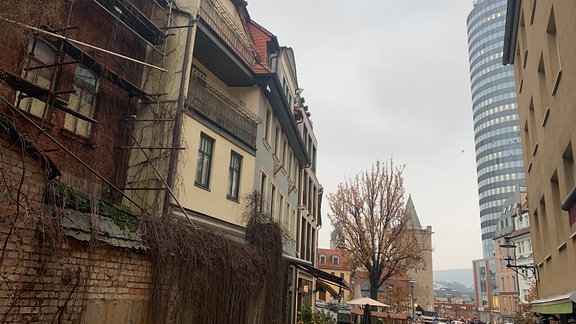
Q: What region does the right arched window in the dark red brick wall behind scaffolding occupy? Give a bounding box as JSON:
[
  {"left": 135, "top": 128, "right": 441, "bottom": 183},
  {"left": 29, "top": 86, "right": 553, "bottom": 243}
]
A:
[{"left": 64, "top": 65, "right": 98, "bottom": 137}]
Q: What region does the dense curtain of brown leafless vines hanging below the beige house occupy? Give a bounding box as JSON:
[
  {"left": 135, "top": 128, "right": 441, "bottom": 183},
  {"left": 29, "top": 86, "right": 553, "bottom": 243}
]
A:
[{"left": 144, "top": 191, "right": 287, "bottom": 324}]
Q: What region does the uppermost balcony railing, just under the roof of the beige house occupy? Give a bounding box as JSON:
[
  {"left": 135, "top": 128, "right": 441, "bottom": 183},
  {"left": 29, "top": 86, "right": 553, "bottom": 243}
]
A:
[{"left": 200, "top": 0, "right": 256, "bottom": 67}]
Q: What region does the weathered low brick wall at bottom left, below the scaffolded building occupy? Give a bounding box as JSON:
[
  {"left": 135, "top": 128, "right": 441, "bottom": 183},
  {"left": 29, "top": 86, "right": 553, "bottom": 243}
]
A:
[{"left": 0, "top": 135, "right": 150, "bottom": 323}]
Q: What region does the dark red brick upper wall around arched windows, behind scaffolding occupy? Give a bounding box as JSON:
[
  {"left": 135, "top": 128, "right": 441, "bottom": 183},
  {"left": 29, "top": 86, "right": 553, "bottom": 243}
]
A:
[{"left": 0, "top": 0, "right": 146, "bottom": 194}]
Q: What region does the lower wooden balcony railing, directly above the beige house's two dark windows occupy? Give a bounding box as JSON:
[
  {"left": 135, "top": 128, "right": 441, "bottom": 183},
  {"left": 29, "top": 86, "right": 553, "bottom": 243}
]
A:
[{"left": 187, "top": 69, "right": 259, "bottom": 148}]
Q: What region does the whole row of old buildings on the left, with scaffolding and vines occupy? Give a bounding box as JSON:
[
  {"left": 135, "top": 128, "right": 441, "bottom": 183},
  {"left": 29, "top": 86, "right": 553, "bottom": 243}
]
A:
[{"left": 0, "top": 0, "right": 347, "bottom": 323}]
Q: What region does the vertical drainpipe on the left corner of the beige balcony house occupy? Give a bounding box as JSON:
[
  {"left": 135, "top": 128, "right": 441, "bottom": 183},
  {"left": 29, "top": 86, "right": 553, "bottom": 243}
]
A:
[{"left": 162, "top": 2, "right": 196, "bottom": 217}]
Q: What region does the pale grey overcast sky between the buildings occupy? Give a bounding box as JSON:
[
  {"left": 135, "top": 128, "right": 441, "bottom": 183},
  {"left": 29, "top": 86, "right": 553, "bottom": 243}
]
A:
[{"left": 248, "top": 0, "right": 482, "bottom": 270}]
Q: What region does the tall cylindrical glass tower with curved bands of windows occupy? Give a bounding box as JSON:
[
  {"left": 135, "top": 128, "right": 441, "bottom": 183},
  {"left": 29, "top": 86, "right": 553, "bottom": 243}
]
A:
[{"left": 467, "top": 0, "right": 526, "bottom": 259}]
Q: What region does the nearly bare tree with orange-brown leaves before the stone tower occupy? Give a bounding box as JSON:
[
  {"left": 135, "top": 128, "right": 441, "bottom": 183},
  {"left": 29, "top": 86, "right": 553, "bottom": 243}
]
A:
[{"left": 327, "top": 159, "right": 426, "bottom": 299}]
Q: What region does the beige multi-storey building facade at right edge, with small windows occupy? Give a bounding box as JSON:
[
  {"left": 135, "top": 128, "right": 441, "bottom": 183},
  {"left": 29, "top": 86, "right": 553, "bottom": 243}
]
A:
[{"left": 504, "top": 0, "right": 576, "bottom": 313}]
